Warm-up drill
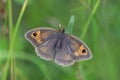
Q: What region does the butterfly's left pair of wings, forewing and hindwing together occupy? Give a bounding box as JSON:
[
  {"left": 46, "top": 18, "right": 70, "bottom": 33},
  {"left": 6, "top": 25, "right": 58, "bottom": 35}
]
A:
[{"left": 25, "top": 28, "right": 57, "bottom": 60}]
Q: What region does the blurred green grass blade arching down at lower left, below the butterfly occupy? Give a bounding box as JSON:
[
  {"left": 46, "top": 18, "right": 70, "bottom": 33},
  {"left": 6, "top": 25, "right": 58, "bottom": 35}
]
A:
[{"left": 0, "top": 51, "right": 52, "bottom": 80}]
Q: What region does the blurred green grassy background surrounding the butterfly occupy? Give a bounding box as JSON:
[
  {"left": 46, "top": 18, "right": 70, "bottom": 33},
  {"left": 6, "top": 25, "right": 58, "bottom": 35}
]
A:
[{"left": 0, "top": 0, "right": 120, "bottom": 80}]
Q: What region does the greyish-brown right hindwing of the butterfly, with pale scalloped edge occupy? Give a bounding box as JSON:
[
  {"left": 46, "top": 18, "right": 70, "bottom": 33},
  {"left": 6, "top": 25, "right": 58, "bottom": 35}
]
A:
[{"left": 55, "top": 39, "right": 74, "bottom": 66}]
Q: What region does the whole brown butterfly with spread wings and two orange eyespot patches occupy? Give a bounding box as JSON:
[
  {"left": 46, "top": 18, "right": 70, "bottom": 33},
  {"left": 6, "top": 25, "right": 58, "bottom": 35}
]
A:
[{"left": 25, "top": 27, "right": 92, "bottom": 66}]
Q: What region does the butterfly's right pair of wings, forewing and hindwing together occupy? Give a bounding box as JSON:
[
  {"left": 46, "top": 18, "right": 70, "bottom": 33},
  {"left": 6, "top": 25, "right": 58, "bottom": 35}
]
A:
[{"left": 55, "top": 35, "right": 92, "bottom": 66}]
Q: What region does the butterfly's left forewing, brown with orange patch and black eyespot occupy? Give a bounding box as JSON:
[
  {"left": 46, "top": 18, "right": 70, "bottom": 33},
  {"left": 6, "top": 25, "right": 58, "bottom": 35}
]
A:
[{"left": 25, "top": 28, "right": 57, "bottom": 47}]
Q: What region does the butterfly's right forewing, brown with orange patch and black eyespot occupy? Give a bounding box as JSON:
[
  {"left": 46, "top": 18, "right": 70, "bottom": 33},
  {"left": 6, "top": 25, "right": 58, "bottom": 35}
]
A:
[{"left": 67, "top": 35, "right": 92, "bottom": 61}]
